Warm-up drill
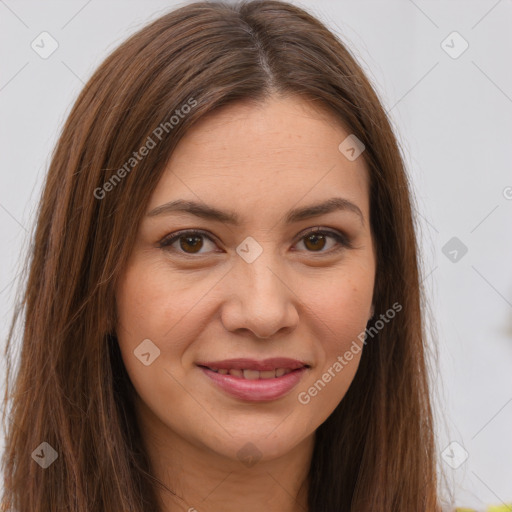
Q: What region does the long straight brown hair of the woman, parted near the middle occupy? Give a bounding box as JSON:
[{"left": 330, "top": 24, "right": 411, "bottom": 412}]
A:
[{"left": 2, "top": 0, "right": 439, "bottom": 512}]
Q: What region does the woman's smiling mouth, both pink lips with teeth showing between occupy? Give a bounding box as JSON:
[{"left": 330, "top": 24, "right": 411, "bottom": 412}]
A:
[{"left": 196, "top": 358, "right": 311, "bottom": 402}]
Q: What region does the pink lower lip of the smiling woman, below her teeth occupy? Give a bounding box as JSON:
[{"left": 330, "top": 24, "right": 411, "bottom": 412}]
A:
[{"left": 200, "top": 366, "right": 307, "bottom": 402}]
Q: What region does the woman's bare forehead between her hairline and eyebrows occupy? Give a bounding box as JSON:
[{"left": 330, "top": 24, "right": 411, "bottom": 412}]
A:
[{"left": 148, "top": 97, "right": 369, "bottom": 223}]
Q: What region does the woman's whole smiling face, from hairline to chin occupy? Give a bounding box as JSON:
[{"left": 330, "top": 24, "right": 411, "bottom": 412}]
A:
[{"left": 116, "top": 93, "right": 375, "bottom": 460}]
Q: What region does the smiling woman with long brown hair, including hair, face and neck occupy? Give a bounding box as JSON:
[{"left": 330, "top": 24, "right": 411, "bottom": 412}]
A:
[{"left": 3, "top": 0, "right": 440, "bottom": 512}]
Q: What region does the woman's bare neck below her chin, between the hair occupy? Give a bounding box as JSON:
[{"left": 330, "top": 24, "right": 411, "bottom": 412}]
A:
[{"left": 135, "top": 396, "right": 314, "bottom": 512}]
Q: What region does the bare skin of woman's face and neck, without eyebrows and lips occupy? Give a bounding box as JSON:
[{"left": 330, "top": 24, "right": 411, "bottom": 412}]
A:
[{"left": 116, "top": 96, "right": 376, "bottom": 512}]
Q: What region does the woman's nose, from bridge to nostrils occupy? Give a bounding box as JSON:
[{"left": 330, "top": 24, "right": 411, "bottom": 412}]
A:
[{"left": 221, "top": 251, "right": 300, "bottom": 339}]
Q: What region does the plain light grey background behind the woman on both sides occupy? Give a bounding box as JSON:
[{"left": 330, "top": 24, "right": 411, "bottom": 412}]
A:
[{"left": 0, "top": 0, "right": 512, "bottom": 510}]
